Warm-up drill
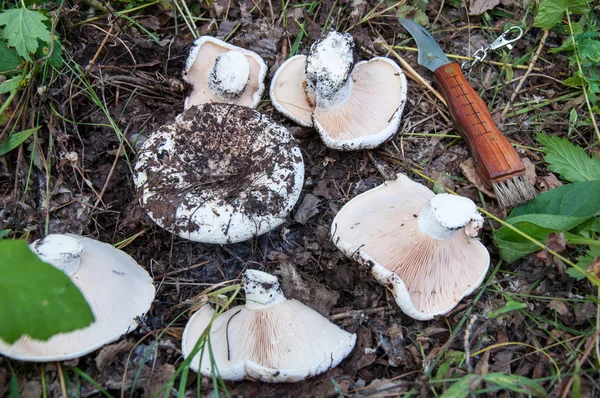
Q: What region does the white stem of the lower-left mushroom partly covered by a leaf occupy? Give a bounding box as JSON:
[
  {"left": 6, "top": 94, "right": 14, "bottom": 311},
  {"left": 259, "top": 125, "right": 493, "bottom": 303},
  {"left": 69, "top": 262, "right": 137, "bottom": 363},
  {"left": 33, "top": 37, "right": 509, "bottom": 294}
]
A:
[{"left": 29, "top": 234, "right": 83, "bottom": 276}]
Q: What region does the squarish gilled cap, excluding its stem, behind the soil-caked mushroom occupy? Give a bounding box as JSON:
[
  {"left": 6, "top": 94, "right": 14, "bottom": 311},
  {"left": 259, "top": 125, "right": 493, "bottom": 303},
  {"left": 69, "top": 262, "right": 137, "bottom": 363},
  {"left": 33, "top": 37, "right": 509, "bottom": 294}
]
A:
[{"left": 183, "top": 36, "right": 267, "bottom": 109}]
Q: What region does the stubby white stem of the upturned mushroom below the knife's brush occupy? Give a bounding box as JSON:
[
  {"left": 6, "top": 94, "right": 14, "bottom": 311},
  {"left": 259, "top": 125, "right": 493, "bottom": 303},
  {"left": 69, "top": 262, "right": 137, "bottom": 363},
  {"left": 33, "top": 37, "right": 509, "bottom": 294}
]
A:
[{"left": 419, "top": 193, "right": 483, "bottom": 240}]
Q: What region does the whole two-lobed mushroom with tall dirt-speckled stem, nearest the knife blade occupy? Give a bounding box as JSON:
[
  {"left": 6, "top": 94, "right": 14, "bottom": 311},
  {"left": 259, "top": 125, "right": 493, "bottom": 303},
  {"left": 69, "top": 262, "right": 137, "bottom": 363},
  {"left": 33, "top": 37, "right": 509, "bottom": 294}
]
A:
[{"left": 270, "top": 30, "right": 407, "bottom": 151}]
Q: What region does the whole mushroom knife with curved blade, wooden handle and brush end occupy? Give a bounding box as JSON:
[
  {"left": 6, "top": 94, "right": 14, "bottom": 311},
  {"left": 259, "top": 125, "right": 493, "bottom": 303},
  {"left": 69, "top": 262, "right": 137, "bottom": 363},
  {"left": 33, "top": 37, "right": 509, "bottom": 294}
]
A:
[{"left": 399, "top": 18, "right": 537, "bottom": 207}]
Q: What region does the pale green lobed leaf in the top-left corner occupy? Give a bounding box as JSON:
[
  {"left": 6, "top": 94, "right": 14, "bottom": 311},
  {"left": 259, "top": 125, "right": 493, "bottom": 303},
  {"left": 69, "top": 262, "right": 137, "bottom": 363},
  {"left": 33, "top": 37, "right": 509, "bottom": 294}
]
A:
[{"left": 0, "top": 8, "right": 50, "bottom": 61}]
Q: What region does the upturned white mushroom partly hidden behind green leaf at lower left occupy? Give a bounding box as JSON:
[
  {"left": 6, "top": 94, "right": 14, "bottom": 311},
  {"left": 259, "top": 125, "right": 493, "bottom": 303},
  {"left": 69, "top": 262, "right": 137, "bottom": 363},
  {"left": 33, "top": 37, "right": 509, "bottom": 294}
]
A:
[{"left": 0, "top": 234, "right": 155, "bottom": 362}]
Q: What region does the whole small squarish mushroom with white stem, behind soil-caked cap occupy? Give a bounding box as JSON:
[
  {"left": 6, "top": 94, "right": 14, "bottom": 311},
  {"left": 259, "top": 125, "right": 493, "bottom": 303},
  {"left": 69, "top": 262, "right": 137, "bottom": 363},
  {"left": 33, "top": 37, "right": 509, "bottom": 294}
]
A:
[{"left": 183, "top": 36, "right": 267, "bottom": 109}]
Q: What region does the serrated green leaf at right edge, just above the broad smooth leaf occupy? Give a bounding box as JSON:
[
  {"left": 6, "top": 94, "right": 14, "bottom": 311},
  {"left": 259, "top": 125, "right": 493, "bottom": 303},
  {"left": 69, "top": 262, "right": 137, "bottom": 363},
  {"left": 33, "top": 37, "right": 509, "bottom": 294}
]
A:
[{"left": 537, "top": 134, "right": 600, "bottom": 182}]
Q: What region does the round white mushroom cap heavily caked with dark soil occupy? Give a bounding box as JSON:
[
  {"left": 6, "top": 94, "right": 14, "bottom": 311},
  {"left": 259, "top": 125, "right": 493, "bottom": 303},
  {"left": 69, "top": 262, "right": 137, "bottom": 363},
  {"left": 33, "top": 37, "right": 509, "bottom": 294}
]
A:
[{"left": 134, "top": 104, "right": 304, "bottom": 244}]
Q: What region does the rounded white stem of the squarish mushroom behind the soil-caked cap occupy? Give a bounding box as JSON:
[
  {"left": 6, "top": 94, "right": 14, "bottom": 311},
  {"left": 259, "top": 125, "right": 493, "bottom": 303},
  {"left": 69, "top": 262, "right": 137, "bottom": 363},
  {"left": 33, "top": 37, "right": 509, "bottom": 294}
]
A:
[{"left": 208, "top": 51, "right": 250, "bottom": 100}]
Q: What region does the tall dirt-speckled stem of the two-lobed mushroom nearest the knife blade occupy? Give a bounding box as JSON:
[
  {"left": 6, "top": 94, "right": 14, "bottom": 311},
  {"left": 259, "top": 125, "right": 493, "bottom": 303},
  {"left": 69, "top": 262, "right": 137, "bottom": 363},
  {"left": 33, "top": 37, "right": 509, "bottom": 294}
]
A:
[{"left": 306, "top": 30, "right": 354, "bottom": 109}]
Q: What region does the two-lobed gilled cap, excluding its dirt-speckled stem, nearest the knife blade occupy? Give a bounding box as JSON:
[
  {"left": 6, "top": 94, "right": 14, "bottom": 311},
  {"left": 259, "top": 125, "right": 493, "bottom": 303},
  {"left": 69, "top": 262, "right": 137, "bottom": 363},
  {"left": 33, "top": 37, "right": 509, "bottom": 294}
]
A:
[{"left": 270, "top": 55, "right": 407, "bottom": 151}]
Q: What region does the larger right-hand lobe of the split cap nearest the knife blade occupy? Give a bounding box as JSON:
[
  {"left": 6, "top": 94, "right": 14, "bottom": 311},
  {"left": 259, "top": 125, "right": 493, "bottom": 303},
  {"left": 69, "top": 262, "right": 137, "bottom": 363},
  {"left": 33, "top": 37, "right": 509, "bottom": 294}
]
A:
[{"left": 312, "top": 57, "right": 407, "bottom": 151}]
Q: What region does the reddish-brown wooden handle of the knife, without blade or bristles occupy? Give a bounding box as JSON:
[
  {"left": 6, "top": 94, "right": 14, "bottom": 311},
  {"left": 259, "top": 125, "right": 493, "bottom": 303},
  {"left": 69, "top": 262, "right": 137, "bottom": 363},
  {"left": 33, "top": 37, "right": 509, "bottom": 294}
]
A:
[{"left": 433, "top": 62, "right": 525, "bottom": 183}]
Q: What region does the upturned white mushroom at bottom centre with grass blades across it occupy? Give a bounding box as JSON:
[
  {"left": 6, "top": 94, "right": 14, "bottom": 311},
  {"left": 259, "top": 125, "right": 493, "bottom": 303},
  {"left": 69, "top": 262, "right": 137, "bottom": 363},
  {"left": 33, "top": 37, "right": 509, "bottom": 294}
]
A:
[{"left": 181, "top": 270, "right": 356, "bottom": 383}]
